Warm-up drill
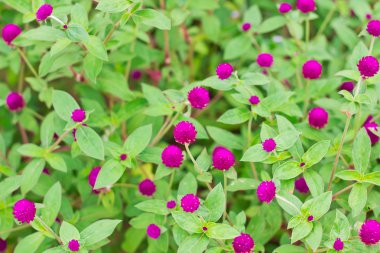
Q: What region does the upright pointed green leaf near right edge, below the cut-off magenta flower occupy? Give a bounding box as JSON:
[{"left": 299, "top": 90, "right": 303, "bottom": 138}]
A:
[{"left": 352, "top": 128, "right": 371, "bottom": 173}]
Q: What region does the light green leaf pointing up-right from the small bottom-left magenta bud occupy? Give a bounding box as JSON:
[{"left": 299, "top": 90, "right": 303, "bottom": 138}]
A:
[{"left": 80, "top": 219, "right": 121, "bottom": 247}]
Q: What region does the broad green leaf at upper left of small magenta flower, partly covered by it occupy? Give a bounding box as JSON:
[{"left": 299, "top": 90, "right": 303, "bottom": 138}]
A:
[{"left": 53, "top": 90, "right": 80, "bottom": 121}]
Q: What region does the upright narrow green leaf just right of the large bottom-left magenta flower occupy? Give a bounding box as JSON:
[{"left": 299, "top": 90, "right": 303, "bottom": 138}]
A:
[{"left": 42, "top": 182, "right": 62, "bottom": 226}]
